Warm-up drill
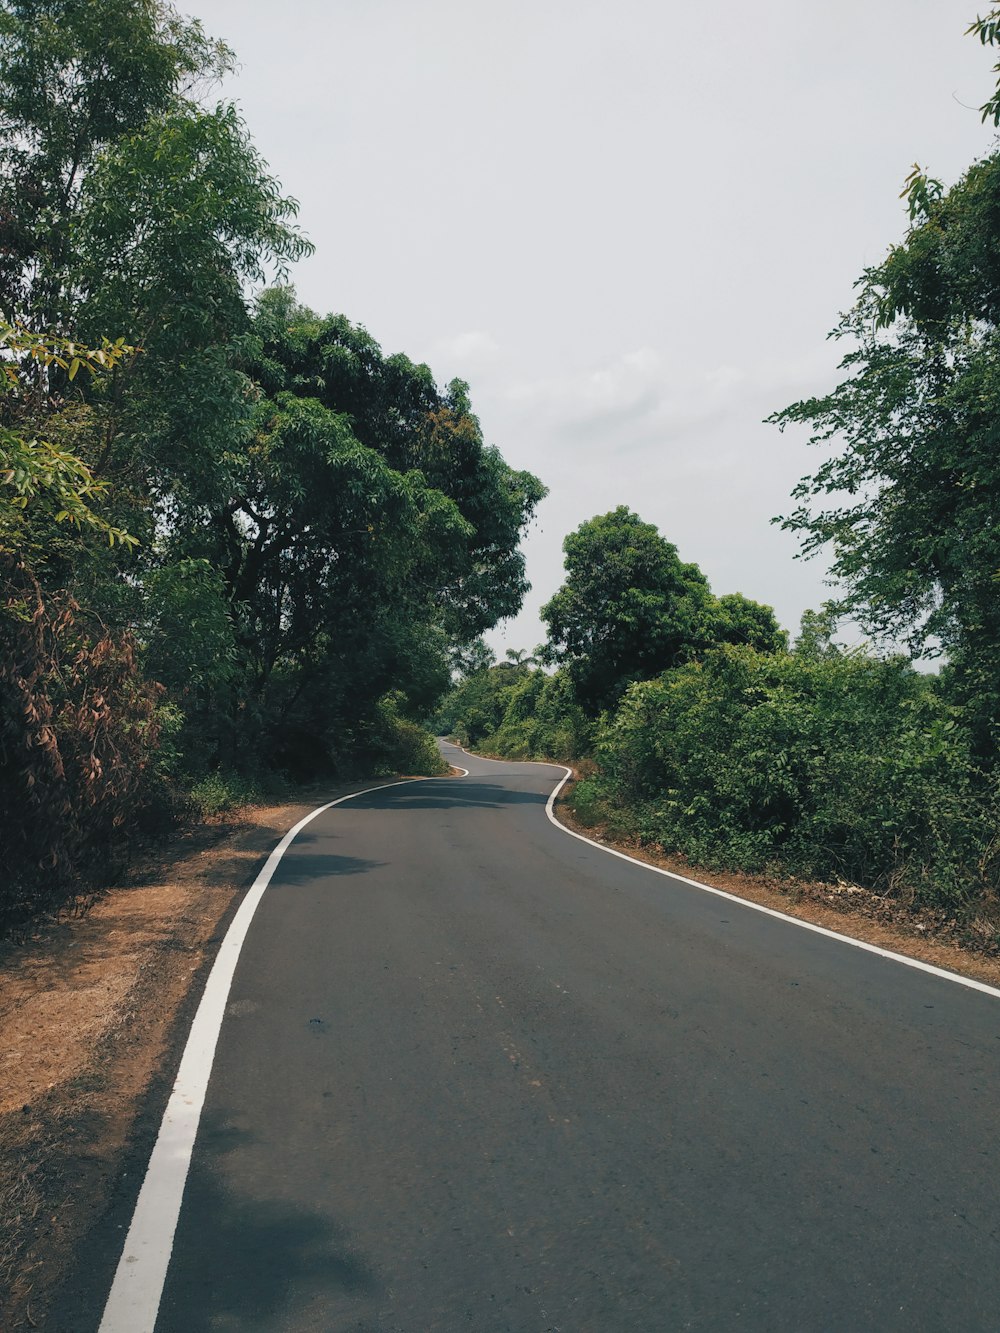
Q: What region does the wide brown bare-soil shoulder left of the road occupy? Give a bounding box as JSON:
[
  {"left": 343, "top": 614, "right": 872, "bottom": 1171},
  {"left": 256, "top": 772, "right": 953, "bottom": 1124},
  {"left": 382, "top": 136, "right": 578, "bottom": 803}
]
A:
[{"left": 0, "top": 784, "right": 364, "bottom": 1333}]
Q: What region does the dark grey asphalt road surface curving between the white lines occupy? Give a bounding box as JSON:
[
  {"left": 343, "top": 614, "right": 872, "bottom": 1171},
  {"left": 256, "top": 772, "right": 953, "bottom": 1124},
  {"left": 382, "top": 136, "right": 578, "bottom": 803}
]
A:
[{"left": 76, "top": 746, "right": 1000, "bottom": 1333}]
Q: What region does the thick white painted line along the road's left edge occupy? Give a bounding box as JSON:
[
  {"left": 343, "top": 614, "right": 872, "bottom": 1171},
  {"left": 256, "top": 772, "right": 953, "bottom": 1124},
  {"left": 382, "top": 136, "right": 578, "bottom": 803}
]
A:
[{"left": 99, "top": 777, "right": 425, "bottom": 1333}]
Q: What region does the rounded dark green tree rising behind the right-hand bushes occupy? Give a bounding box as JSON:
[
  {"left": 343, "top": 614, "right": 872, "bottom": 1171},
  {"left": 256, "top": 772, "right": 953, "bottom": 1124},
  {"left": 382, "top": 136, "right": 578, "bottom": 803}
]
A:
[{"left": 541, "top": 505, "right": 712, "bottom": 713}]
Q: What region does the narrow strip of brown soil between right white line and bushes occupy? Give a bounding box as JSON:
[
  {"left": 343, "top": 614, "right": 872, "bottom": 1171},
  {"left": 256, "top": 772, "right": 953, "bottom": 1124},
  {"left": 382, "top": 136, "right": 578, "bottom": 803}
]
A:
[{"left": 557, "top": 785, "right": 1000, "bottom": 986}]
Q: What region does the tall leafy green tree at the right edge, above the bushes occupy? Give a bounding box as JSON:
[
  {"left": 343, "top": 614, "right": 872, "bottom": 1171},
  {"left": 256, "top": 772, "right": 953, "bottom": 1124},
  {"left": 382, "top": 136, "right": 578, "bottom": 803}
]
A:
[{"left": 769, "top": 123, "right": 1000, "bottom": 753}]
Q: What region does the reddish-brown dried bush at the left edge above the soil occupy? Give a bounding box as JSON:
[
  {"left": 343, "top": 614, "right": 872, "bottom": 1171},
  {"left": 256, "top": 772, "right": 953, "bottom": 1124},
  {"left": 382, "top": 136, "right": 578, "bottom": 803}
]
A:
[{"left": 0, "top": 555, "right": 161, "bottom": 932}]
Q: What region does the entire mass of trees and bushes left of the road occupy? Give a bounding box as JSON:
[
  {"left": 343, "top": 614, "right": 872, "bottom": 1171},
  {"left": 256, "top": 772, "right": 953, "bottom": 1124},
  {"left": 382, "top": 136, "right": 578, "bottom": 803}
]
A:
[{"left": 0, "top": 0, "right": 544, "bottom": 933}]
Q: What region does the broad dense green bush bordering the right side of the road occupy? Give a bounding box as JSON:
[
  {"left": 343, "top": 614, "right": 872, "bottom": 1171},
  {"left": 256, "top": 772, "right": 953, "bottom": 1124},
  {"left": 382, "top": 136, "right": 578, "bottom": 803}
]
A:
[{"left": 577, "top": 647, "right": 1000, "bottom": 904}]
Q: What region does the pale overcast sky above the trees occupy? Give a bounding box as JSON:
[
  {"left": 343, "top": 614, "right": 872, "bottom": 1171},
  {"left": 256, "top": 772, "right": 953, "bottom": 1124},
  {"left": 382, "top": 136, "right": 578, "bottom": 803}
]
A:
[{"left": 176, "top": 0, "right": 995, "bottom": 651}]
